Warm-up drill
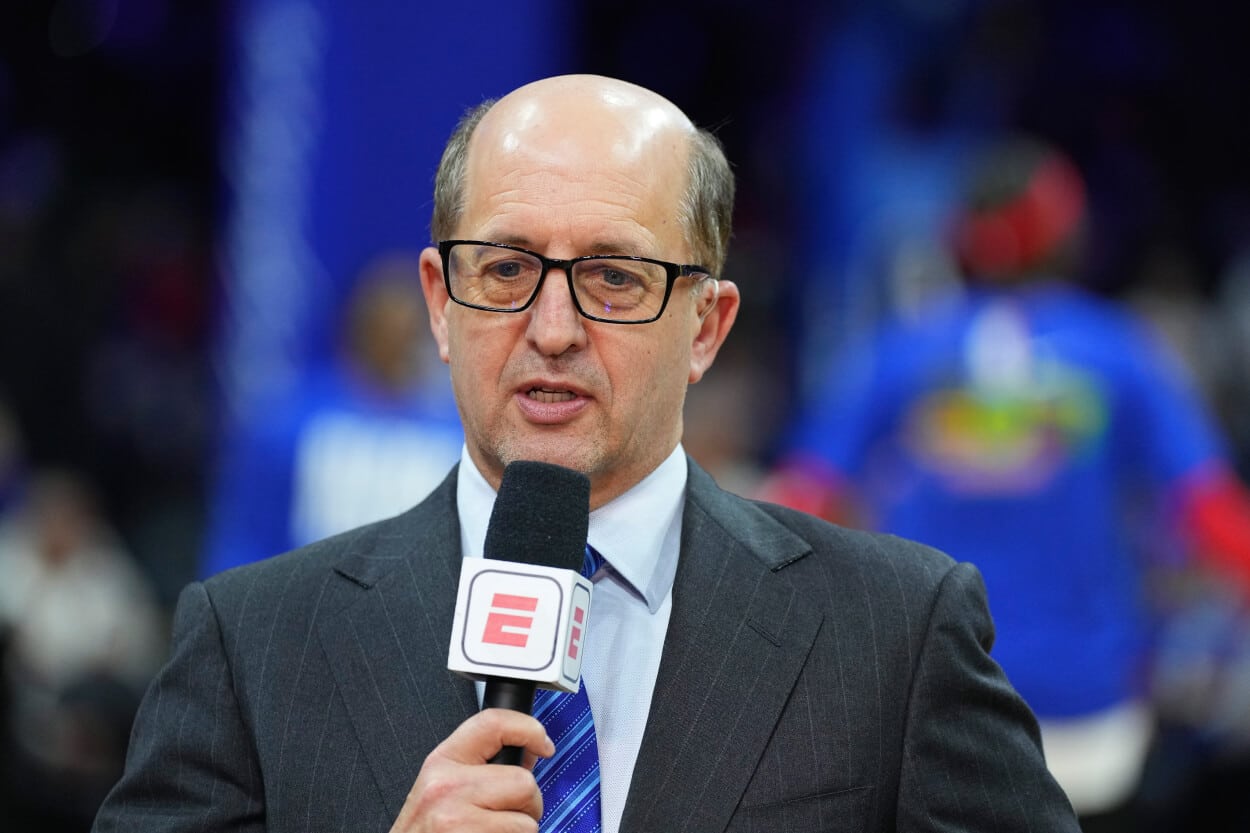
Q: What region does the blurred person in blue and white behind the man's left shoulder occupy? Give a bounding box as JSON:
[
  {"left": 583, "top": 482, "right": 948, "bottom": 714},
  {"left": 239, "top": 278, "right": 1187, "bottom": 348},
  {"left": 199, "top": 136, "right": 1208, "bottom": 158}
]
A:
[{"left": 201, "top": 255, "right": 464, "bottom": 575}]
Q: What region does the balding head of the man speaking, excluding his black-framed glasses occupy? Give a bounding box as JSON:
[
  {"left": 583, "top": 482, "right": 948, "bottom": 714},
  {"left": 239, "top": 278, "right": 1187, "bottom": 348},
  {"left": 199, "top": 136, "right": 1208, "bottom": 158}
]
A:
[{"left": 421, "top": 75, "right": 739, "bottom": 507}]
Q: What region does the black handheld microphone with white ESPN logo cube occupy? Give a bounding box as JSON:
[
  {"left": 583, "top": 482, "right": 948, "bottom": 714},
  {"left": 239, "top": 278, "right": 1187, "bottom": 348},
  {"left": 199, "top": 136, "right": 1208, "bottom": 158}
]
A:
[{"left": 448, "top": 460, "right": 594, "bottom": 764}]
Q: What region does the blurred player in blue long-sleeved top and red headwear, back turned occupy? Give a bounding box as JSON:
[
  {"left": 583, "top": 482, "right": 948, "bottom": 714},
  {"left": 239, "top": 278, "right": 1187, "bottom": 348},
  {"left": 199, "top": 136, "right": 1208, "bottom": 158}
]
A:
[{"left": 763, "top": 138, "right": 1250, "bottom": 830}]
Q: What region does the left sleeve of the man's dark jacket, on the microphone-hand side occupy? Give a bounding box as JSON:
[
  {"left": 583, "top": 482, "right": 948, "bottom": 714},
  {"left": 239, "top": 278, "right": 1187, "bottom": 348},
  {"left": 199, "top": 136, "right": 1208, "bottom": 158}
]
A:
[{"left": 93, "top": 583, "right": 265, "bottom": 833}]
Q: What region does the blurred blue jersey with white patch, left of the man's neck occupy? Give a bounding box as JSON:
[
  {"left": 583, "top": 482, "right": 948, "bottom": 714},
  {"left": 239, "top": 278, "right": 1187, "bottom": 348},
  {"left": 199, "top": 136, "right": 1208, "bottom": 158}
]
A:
[{"left": 200, "top": 368, "right": 464, "bottom": 575}]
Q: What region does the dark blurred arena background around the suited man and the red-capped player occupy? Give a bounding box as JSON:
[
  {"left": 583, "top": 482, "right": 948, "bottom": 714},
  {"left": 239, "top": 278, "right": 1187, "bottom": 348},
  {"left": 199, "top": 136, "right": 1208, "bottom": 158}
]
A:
[{"left": 0, "top": 0, "right": 1250, "bottom": 830}]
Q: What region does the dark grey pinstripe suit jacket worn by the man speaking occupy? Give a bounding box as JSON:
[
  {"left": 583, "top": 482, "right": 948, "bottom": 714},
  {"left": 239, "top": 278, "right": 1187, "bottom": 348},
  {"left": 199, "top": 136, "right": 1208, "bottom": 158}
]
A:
[{"left": 95, "top": 462, "right": 1078, "bottom": 833}]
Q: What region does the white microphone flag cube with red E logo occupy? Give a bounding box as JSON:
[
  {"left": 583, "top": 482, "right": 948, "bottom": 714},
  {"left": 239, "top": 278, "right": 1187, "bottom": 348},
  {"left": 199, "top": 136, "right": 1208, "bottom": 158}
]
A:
[{"left": 448, "top": 558, "right": 594, "bottom": 693}]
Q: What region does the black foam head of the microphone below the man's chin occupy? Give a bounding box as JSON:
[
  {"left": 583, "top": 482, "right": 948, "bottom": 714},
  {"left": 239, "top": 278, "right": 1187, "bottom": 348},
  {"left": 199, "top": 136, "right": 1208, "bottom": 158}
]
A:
[{"left": 484, "top": 460, "right": 590, "bottom": 570}]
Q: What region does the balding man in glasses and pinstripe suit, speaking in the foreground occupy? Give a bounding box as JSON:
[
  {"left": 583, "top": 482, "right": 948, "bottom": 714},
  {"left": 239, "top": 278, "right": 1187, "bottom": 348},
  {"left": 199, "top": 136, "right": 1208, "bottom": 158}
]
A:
[{"left": 95, "top": 76, "right": 1075, "bottom": 833}]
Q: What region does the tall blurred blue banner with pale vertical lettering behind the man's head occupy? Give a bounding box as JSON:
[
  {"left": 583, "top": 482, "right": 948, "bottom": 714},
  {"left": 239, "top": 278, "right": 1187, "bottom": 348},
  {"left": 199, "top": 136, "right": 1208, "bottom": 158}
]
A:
[{"left": 218, "top": 0, "right": 576, "bottom": 422}]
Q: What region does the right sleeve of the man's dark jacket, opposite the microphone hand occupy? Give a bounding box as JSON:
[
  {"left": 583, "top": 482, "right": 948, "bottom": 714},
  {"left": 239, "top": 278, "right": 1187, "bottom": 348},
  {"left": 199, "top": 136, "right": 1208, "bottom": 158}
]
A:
[{"left": 898, "top": 564, "right": 1079, "bottom": 833}]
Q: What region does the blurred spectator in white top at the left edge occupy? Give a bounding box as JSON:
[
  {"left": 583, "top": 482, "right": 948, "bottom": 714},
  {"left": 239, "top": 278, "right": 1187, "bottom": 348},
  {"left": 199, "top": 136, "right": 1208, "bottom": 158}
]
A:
[{"left": 0, "top": 470, "right": 166, "bottom": 832}]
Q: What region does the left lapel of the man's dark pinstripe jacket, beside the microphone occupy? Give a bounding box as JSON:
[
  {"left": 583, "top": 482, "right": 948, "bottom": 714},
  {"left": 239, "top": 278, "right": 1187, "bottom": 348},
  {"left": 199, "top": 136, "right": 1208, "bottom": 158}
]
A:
[{"left": 319, "top": 470, "right": 478, "bottom": 817}]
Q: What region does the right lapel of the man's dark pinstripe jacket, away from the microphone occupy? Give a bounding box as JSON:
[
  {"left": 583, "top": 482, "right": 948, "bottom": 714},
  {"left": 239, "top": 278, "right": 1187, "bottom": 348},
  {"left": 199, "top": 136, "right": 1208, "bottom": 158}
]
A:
[{"left": 621, "top": 462, "right": 823, "bottom": 833}]
